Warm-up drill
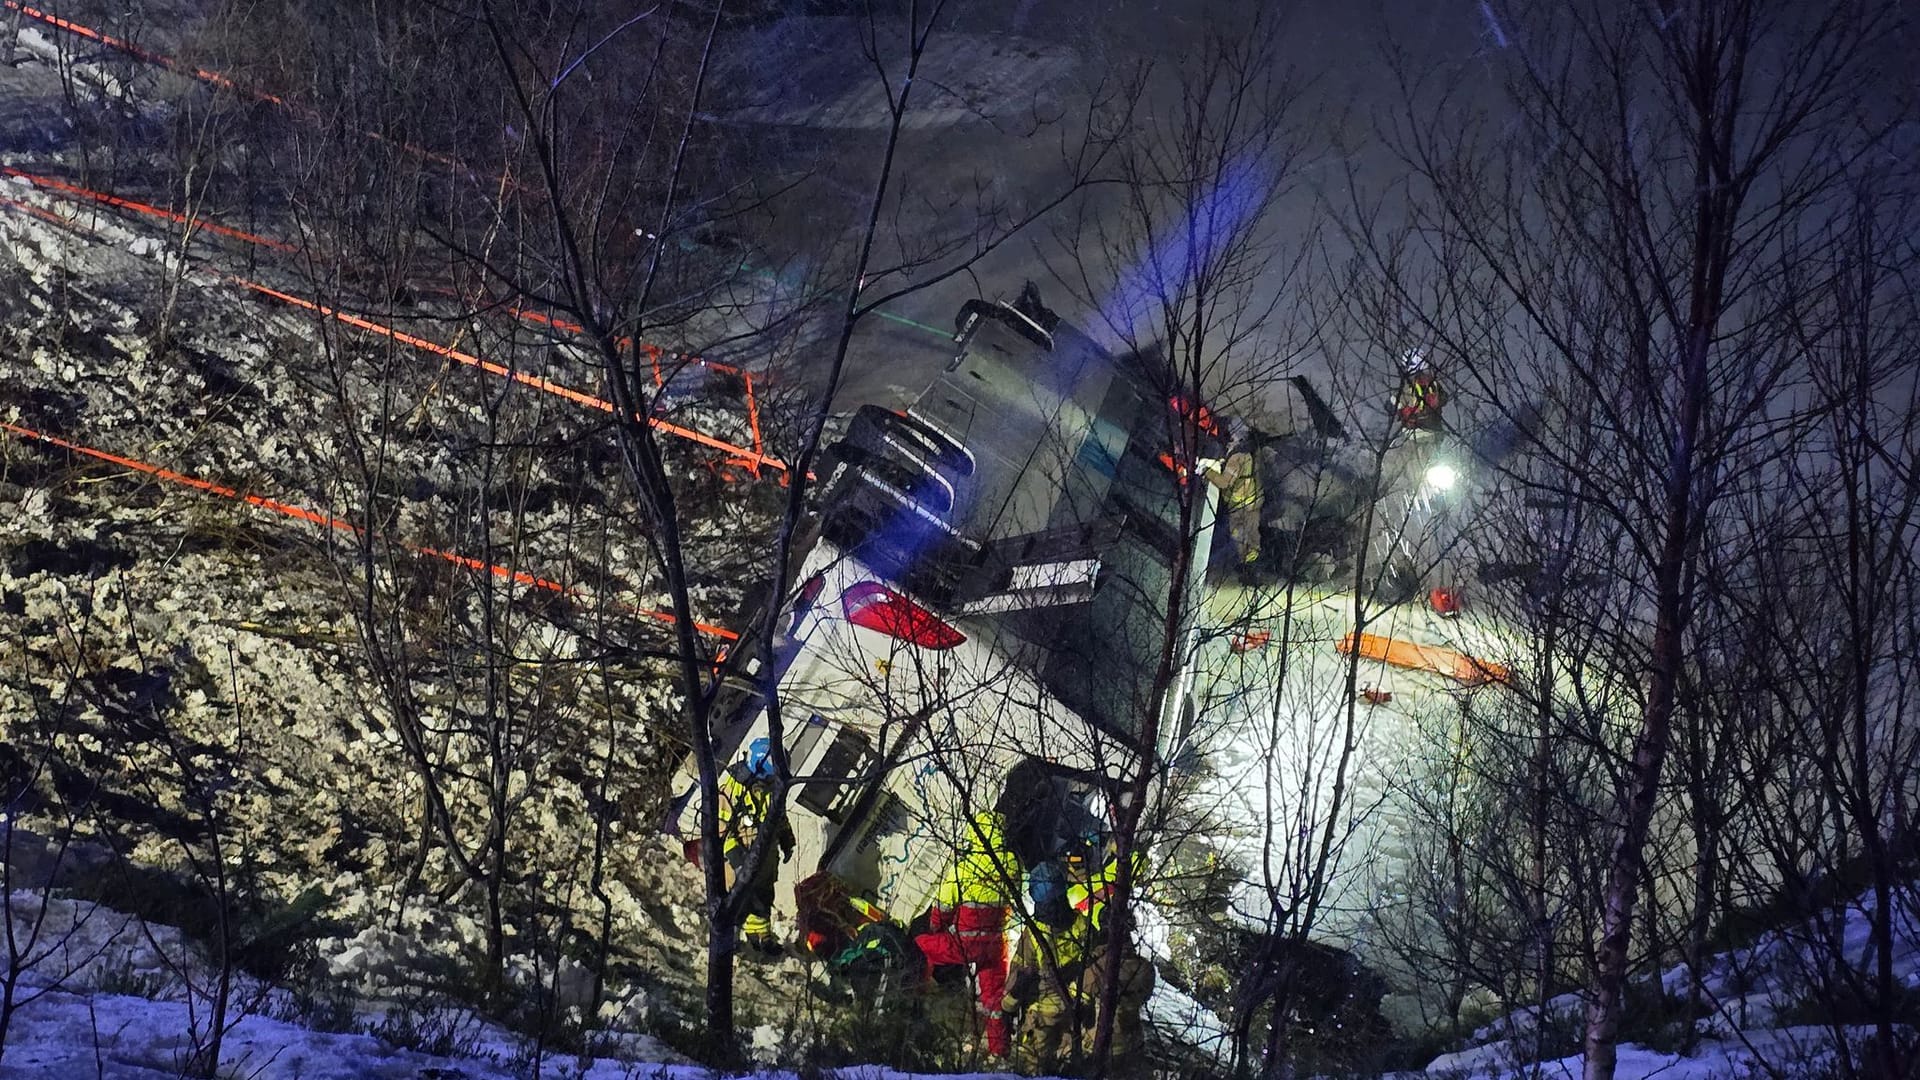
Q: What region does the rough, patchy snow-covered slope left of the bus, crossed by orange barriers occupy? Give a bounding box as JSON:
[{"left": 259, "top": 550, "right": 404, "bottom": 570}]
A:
[{"left": 0, "top": 8, "right": 801, "bottom": 1076}]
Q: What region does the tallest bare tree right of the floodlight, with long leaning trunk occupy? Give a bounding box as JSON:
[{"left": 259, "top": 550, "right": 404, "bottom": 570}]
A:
[{"left": 1394, "top": 0, "right": 1899, "bottom": 1080}]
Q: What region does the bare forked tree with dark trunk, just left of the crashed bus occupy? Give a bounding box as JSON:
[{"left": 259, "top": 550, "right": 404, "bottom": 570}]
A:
[{"left": 447, "top": 2, "right": 1136, "bottom": 1049}]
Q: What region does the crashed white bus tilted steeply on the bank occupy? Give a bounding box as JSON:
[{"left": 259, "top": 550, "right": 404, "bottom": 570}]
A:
[{"left": 674, "top": 286, "right": 1221, "bottom": 919}]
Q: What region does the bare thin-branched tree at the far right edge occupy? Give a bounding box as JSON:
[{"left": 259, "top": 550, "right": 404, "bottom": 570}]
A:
[{"left": 1728, "top": 169, "right": 1920, "bottom": 1076}]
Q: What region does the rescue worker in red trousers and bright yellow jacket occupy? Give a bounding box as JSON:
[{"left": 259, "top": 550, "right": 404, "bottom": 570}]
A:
[{"left": 914, "top": 811, "right": 1021, "bottom": 1057}]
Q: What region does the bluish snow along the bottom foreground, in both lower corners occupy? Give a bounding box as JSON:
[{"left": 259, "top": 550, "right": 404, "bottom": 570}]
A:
[{"left": 0, "top": 876, "right": 1920, "bottom": 1080}]
